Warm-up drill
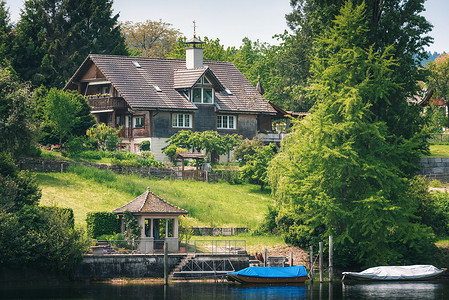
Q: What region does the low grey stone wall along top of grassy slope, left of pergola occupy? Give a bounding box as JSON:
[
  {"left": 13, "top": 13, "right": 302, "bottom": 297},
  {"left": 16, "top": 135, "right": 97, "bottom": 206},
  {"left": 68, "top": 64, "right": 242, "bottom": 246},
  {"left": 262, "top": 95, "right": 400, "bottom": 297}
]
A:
[{"left": 17, "top": 158, "right": 175, "bottom": 178}]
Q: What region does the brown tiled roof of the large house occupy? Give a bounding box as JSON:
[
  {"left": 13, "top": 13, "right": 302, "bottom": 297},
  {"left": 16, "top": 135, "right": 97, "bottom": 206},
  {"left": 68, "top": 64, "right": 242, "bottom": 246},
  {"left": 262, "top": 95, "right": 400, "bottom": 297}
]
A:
[{"left": 66, "top": 54, "right": 276, "bottom": 114}]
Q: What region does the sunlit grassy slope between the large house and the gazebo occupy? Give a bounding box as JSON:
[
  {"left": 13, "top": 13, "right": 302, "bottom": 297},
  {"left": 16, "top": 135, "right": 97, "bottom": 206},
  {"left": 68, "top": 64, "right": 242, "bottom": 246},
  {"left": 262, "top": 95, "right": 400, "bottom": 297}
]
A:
[{"left": 37, "top": 168, "right": 272, "bottom": 228}]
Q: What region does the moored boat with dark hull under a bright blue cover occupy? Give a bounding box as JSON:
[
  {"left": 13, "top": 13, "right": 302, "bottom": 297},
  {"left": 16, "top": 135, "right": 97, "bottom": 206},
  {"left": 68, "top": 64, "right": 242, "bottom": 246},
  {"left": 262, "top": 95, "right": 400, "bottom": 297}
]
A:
[{"left": 226, "top": 266, "right": 309, "bottom": 284}]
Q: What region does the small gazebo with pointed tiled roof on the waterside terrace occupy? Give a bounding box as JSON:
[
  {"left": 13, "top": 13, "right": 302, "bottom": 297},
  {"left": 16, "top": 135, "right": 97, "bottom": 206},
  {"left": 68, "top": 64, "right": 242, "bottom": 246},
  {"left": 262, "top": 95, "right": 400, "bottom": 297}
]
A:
[{"left": 112, "top": 187, "right": 188, "bottom": 253}]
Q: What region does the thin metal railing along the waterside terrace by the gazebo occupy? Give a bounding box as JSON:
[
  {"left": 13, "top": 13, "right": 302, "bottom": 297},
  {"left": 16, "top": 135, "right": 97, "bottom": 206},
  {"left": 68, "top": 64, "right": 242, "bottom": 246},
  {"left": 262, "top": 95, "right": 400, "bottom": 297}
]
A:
[{"left": 88, "top": 240, "right": 246, "bottom": 255}]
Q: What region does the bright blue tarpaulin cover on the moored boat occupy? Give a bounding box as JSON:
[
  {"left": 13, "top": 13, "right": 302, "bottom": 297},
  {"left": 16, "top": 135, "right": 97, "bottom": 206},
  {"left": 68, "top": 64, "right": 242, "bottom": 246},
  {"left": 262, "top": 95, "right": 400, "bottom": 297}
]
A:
[{"left": 228, "top": 266, "right": 307, "bottom": 278}]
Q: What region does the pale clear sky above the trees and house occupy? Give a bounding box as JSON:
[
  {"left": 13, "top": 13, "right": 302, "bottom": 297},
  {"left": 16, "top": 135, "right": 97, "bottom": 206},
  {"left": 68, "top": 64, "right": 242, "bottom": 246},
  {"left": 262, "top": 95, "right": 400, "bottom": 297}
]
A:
[{"left": 6, "top": 0, "right": 449, "bottom": 53}]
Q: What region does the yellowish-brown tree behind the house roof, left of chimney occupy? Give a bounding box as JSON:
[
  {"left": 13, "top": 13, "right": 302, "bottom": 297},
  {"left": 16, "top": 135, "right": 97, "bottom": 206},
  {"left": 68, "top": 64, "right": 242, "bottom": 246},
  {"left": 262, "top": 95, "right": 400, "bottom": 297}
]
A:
[{"left": 120, "top": 20, "right": 181, "bottom": 57}]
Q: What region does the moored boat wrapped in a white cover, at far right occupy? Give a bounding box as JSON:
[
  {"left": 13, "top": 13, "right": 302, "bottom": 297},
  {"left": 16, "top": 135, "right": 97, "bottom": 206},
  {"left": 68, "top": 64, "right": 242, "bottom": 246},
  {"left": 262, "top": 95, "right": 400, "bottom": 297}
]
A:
[{"left": 343, "top": 265, "right": 444, "bottom": 280}]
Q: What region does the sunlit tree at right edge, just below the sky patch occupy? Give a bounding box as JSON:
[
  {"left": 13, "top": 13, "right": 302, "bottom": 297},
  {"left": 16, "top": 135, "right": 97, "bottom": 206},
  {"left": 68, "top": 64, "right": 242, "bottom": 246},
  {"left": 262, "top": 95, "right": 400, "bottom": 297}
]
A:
[{"left": 428, "top": 53, "right": 449, "bottom": 124}]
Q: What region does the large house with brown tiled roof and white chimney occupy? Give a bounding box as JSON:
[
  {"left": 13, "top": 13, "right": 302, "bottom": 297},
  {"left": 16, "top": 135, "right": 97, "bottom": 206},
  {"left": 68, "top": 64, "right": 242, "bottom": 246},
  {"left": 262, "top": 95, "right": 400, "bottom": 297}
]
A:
[{"left": 64, "top": 37, "right": 277, "bottom": 161}]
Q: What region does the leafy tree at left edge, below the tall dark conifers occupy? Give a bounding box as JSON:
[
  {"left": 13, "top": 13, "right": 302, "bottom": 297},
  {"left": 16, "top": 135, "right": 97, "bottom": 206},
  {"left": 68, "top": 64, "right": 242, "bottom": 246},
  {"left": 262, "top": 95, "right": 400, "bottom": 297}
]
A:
[{"left": 0, "top": 65, "right": 34, "bottom": 156}]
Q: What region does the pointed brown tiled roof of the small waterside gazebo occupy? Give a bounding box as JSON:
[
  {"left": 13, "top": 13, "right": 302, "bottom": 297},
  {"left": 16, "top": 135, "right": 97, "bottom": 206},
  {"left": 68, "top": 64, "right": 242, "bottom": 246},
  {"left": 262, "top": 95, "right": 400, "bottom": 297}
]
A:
[{"left": 112, "top": 187, "right": 188, "bottom": 215}]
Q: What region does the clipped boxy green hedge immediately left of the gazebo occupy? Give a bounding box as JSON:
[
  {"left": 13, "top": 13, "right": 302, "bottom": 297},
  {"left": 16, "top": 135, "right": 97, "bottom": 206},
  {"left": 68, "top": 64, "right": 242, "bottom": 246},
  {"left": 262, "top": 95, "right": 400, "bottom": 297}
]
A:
[{"left": 86, "top": 212, "right": 120, "bottom": 239}]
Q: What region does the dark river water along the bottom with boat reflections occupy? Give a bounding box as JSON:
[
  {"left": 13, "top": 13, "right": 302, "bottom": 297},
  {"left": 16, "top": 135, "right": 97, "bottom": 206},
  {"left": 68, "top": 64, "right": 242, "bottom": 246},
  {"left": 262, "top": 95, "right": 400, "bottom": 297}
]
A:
[{"left": 0, "top": 281, "right": 449, "bottom": 300}]
